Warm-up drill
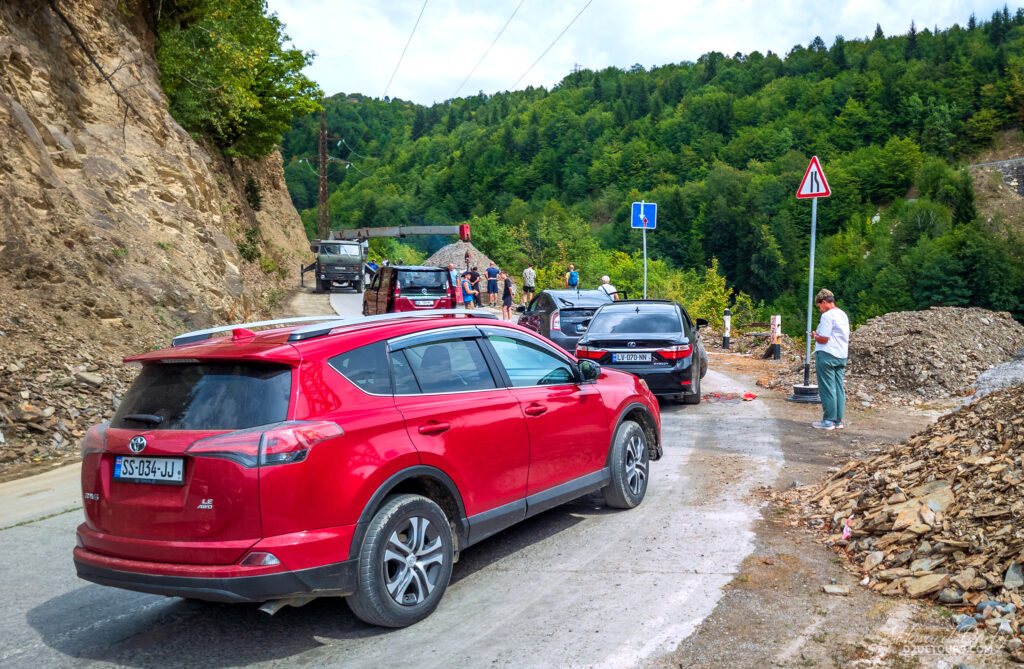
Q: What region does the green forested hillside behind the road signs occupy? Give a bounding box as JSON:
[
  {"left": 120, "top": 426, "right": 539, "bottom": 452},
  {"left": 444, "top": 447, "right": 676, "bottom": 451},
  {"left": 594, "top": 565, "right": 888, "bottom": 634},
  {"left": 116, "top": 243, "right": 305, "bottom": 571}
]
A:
[{"left": 284, "top": 8, "right": 1024, "bottom": 330}]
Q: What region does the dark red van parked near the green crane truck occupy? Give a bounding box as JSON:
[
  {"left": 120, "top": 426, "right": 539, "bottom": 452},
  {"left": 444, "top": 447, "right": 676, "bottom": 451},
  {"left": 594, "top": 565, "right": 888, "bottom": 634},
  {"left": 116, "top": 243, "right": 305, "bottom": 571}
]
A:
[{"left": 362, "top": 265, "right": 456, "bottom": 316}]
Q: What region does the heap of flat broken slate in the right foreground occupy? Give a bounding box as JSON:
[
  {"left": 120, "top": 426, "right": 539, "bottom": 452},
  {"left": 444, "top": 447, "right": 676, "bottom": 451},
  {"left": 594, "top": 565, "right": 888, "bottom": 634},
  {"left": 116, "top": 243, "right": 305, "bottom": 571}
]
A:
[{"left": 777, "top": 385, "right": 1024, "bottom": 634}]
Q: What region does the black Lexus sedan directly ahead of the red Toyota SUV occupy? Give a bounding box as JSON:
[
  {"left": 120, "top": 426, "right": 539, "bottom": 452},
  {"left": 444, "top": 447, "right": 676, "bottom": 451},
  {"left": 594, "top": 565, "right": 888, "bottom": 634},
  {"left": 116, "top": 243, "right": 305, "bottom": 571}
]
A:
[{"left": 575, "top": 300, "right": 708, "bottom": 405}]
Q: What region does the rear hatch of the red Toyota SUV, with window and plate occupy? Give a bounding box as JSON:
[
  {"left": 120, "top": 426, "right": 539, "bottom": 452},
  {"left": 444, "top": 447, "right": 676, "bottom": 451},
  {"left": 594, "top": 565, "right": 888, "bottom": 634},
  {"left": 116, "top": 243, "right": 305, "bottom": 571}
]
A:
[{"left": 82, "top": 360, "right": 292, "bottom": 565}]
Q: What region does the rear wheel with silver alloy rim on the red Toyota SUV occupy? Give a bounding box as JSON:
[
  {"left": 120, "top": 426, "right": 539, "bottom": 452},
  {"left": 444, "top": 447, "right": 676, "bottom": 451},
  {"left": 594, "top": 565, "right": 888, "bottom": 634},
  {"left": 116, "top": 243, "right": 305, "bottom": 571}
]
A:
[{"left": 347, "top": 495, "right": 455, "bottom": 627}]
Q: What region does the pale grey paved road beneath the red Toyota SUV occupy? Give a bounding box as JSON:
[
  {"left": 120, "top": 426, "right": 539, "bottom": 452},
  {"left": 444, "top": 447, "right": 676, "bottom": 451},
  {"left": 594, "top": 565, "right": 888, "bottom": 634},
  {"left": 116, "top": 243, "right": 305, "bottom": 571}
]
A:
[{"left": 0, "top": 293, "right": 782, "bottom": 667}]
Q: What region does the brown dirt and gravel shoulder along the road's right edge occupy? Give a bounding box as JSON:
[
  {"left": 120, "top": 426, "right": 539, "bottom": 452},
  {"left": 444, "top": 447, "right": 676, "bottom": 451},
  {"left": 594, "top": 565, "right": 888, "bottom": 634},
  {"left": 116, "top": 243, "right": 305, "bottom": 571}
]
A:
[{"left": 642, "top": 353, "right": 1011, "bottom": 668}]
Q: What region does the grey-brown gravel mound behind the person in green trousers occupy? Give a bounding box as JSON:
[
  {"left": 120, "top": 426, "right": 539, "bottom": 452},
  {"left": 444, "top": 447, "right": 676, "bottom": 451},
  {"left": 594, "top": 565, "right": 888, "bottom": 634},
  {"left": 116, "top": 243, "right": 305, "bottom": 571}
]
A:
[{"left": 773, "top": 306, "right": 1024, "bottom": 406}]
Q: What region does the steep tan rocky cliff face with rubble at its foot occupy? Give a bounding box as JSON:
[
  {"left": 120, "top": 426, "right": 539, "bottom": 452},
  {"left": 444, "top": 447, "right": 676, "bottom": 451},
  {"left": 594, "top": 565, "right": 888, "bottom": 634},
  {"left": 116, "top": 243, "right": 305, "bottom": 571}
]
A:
[{"left": 0, "top": 0, "right": 308, "bottom": 477}]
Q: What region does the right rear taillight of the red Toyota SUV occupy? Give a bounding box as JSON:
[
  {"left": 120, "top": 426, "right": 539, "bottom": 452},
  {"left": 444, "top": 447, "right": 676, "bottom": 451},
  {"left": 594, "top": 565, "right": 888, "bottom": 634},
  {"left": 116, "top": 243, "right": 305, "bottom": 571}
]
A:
[{"left": 185, "top": 420, "right": 344, "bottom": 467}]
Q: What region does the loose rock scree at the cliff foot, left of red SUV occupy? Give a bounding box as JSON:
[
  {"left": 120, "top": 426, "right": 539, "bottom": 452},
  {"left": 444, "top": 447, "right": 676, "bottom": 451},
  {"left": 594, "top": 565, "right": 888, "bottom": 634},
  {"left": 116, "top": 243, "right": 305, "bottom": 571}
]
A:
[{"left": 0, "top": 302, "right": 160, "bottom": 477}]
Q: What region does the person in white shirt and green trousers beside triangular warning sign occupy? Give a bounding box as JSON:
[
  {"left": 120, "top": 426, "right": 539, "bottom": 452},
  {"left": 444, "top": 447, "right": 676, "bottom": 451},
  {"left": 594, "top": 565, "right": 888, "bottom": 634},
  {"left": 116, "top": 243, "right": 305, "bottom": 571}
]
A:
[{"left": 807, "top": 288, "right": 850, "bottom": 429}]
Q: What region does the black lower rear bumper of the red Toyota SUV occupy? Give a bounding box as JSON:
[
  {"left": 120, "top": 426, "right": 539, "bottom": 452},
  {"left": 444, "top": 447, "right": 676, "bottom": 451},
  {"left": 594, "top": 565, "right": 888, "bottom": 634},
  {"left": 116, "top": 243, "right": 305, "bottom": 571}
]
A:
[{"left": 75, "top": 548, "right": 357, "bottom": 602}]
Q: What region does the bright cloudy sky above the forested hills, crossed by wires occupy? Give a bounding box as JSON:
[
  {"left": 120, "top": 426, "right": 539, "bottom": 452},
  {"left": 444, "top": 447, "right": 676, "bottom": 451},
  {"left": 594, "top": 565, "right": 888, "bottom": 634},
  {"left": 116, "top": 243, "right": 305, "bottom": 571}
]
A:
[{"left": 268, "top": 0, "right": 1015, "bottom": 104}]
